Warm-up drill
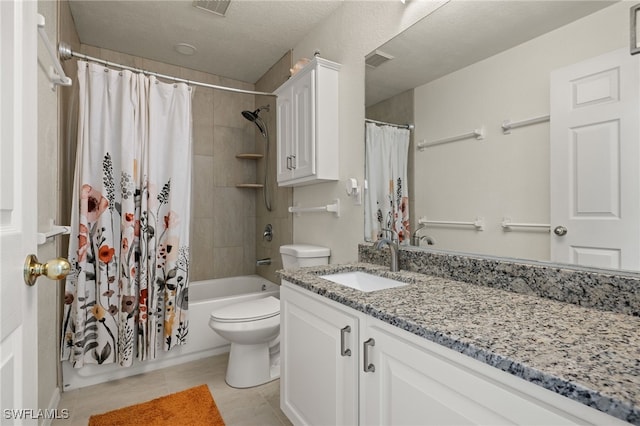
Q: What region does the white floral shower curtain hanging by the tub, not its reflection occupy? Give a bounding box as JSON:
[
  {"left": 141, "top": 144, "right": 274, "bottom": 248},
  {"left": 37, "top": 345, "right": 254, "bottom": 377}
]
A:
[{"left": 61, "top": 61, "right": 191, "bottom": 367}]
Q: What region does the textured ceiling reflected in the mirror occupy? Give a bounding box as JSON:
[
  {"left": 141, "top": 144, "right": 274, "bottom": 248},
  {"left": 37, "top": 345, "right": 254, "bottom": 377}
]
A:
[{"left": 366, "top": 0, "right": 618, "bottom": 106}]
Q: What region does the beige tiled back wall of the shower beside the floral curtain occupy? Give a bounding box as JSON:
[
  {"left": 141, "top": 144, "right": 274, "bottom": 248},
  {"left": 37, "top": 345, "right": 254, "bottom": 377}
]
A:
[{"left": 65, "top": 45, "right": 262, "bottom": 281}]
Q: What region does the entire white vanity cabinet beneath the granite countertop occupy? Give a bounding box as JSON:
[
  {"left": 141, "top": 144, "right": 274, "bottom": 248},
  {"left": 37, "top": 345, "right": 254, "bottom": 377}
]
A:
[{"left": 280, "top": 280, "right": 627, "bottom": 426}]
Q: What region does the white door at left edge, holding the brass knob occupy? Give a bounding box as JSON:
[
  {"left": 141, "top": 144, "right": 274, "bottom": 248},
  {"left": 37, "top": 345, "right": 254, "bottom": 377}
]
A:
[{"left": 0, "top": 0, "right": 38, "bottom": 425}]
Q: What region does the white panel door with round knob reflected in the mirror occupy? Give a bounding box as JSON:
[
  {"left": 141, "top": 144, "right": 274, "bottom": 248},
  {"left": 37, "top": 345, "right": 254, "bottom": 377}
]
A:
[{"left": 550, "top": 48, "right": 640, "bottom": 270}]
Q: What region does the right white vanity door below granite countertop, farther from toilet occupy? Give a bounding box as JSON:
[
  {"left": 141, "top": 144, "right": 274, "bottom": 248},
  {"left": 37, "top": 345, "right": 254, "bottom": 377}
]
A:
[{"left": 360, "top": 318, "right": 624, "bottom": 426}]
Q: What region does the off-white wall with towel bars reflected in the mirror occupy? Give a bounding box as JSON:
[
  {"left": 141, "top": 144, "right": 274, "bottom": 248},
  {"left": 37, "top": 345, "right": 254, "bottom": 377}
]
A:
[{"left": 414, "top": 2, "right": 631, "bottom": 260}]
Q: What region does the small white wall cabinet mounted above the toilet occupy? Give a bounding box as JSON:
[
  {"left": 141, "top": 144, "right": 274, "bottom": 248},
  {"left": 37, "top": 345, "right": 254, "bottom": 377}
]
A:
[{"left": 275, "top": 57, "right": 340, "bottom": 186}]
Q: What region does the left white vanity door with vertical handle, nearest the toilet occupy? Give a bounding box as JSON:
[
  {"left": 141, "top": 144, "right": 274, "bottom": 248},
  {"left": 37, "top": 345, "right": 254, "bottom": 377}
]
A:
[{"left": 280, "top": 281, "right": 359, "bottom": 425}]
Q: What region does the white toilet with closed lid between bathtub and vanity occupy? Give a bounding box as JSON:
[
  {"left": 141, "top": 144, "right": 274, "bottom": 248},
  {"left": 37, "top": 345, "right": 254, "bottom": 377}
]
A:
[{"left": 209, "top": 244, "right": 331, "bottom": 388}]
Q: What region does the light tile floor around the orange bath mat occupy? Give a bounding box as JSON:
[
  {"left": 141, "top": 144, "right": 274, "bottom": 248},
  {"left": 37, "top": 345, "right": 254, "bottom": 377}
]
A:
[{"left": 52, "top": 354, "right": 291, "bottom": 426}]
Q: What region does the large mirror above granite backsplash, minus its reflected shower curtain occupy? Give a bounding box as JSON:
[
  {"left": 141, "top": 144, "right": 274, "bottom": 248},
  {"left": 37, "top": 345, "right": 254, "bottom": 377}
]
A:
[{"left": 366, "top": 0, "right": 640, "bottom": 270}]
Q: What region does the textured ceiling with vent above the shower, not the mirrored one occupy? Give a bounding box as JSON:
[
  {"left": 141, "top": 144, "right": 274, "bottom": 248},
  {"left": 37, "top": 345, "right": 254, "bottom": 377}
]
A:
[{"left": 69, "top": 0, "right": 342, "bottom": 83}]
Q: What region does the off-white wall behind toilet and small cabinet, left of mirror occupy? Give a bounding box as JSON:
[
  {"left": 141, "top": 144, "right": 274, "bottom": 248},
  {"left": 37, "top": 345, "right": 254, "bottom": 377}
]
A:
[{"left": 293, "top": 0, "right": 442, "bottom": 263}]
